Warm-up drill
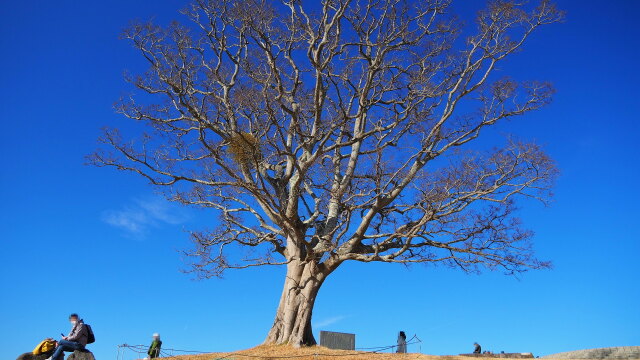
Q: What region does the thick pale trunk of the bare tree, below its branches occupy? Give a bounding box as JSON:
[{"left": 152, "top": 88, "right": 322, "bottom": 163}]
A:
[{"left": 265, "top": 260, "right": 329, "bottom": 347}]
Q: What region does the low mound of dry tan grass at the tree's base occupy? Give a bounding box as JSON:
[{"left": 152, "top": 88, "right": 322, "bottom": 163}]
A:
[{"left": 160, "top": 345, "right": 528, "bottom": 360}]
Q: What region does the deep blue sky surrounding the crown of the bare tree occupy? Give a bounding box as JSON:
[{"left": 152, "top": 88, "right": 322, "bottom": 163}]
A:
[{"left": 0, "top": 0, "right": 640, "bottom": 360}]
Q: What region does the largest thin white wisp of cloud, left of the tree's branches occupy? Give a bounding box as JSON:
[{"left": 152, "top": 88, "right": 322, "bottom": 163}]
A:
[{"left": 102, "top": 198, "right": 189, "bottom": 237}]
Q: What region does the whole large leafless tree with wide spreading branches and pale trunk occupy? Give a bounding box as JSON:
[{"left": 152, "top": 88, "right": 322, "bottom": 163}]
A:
[{"left": 91, "top": 0, "right": 562, "bottom": 345}]
